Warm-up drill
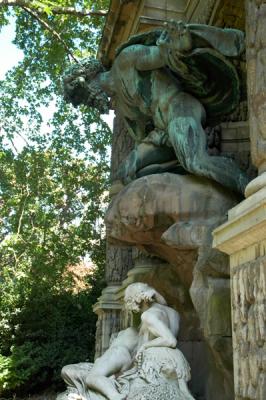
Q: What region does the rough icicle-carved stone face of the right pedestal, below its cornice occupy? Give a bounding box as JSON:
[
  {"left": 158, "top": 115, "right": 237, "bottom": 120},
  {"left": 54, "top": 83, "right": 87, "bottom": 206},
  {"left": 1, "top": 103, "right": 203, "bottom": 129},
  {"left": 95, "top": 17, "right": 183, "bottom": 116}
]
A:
[{"left": 231, "top": 255, "right": 266, "bottom": 400}]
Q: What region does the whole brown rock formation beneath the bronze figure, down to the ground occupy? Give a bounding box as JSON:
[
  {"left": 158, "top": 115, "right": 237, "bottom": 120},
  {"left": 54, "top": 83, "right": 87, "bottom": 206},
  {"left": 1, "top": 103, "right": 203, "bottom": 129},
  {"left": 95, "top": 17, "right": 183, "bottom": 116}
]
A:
[{"left": 106, "top": 173, "right": 238, "bottom": 400}]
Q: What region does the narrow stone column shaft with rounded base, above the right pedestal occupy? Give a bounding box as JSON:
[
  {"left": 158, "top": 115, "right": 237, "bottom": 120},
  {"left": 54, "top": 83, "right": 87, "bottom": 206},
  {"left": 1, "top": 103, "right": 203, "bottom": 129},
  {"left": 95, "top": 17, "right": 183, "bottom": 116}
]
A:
[{"left": 246, "top": 0, "right": 266, "bottom": 197}]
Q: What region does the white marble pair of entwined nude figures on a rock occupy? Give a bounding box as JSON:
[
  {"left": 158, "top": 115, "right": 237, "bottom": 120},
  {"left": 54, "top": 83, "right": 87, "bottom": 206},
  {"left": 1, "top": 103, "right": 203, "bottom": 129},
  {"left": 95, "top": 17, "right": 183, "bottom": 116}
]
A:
[{"left": 58, "top": 283, "right": 193, "bottom": 400}]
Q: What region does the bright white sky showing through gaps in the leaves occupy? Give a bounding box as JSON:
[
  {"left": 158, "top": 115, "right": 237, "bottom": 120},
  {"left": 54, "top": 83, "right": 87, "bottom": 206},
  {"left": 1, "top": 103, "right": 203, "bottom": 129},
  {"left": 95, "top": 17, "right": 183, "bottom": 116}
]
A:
[{"left": 0, "top": 18, "right": 114, "bottom": 149}]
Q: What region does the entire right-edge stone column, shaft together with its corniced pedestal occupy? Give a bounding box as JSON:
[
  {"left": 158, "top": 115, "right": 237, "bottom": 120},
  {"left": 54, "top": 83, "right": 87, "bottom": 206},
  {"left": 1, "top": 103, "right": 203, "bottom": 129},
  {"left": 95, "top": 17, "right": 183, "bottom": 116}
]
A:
[{"left": 213, "top": 0, "right": 266, "bottom": 400}]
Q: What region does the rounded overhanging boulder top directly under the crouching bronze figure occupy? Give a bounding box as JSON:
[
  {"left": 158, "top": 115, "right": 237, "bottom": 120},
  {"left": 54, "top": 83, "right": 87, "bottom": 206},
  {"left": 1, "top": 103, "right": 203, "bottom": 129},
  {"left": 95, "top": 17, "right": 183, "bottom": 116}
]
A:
[{"left": 106, "top": 173, "right": 237, "bottom": 266}]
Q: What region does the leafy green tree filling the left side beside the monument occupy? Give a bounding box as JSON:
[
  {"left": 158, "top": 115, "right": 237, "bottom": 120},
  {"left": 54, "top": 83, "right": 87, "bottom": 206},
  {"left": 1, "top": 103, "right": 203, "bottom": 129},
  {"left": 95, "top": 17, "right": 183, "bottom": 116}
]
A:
[{"left": 0, "top": 0, "right": 110, "bottom": 393}]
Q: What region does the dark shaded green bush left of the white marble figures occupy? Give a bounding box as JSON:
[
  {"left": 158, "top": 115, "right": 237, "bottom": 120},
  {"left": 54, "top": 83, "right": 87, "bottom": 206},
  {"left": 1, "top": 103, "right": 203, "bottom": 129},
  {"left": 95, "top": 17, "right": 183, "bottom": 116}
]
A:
[{"left": 0, "top": 288, "right": 105, "bottom": 393}]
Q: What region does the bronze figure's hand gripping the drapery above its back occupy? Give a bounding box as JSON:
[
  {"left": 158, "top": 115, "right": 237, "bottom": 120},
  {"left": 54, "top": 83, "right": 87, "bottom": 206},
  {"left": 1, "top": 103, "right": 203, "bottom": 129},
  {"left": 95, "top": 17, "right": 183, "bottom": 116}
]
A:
[{"left": 157, "top": 20, "right": 192, "bottom": 53}]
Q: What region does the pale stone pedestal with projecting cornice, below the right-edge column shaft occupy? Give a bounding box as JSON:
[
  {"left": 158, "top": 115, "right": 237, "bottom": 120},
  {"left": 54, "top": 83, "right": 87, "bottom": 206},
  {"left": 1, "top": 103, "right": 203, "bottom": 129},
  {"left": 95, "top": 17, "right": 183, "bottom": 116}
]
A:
[{"left": 213, "top": 188, "right": 266, "bottom": 400}]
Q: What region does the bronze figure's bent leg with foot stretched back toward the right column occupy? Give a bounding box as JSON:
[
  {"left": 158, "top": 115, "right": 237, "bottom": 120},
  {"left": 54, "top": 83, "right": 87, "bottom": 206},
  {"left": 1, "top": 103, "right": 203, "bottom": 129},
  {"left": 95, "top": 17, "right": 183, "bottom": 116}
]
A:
[{"left": 168, "top": 92, "right": 249, "bottom": 193}]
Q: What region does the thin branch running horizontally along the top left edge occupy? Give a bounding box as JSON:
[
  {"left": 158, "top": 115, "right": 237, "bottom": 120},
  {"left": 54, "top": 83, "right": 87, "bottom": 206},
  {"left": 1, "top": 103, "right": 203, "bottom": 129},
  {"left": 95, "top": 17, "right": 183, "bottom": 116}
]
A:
[{"left": 0, "top": 0, "right": 108, "bottom": 18}]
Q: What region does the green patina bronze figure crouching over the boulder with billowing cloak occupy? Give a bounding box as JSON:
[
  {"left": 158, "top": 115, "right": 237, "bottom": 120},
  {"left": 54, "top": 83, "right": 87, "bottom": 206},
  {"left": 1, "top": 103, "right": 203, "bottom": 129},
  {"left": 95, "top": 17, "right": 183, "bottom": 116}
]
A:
[{"left": 64, "top": 21, "right": 248, "bottom": 193}]
